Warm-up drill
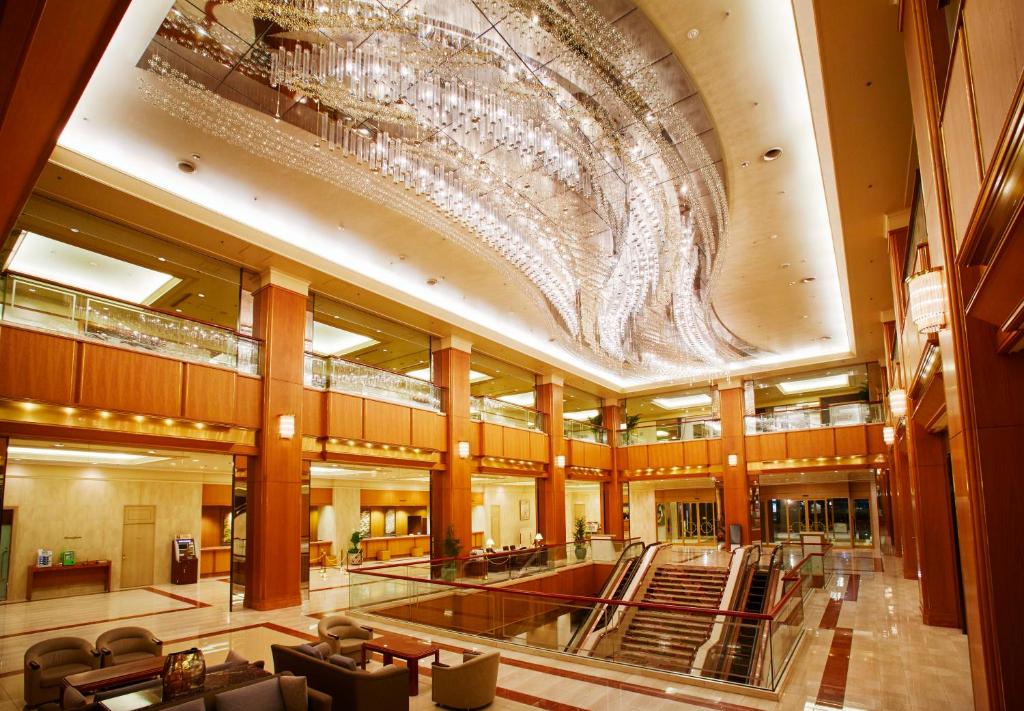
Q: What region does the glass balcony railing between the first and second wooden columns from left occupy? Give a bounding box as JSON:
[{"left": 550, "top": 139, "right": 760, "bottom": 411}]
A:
[{"left": 304, "top": 353, "right": 441, "bottom": 412}]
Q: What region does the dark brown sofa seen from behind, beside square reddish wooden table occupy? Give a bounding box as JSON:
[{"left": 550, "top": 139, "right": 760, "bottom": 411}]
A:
[{"left": 270, "top": 644, "right": 409, "bottom": 711}]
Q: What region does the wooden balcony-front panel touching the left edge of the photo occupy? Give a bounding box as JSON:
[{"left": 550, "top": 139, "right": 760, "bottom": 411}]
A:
[{"left": 0, "top": 326, "right": 77, "bottom": 405}]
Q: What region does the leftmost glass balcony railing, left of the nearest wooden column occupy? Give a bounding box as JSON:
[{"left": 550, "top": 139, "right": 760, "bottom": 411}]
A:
[{"left": 0, "top": 274, "right": 260, "bottom": 375}]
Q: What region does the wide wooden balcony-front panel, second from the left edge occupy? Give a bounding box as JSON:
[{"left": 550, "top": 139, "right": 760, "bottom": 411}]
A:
[{"left": 79, "top": 343, "right": 184, "bottom": 417}]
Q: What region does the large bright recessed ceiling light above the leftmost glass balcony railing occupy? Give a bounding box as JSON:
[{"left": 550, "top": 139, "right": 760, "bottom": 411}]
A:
[{"left": 8, "top": 232, "right": 181, "bottom": 304}]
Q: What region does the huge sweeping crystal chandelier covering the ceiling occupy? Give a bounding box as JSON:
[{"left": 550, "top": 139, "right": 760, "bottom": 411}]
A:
[{"left": 140, "top": 0, "right": 754, "bottom": 373}]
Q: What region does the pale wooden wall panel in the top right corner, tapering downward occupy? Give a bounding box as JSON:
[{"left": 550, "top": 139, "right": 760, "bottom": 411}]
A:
[{"left": 964, "top": 0, "right": 1024, "bottom": 169}]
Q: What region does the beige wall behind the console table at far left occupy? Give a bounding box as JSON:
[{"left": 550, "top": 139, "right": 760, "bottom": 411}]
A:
[{"left": 3, "top": 463, "right": 203, "bottom": 599}]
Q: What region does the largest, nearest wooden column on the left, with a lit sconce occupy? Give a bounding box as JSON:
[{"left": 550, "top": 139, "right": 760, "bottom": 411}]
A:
[{"left": 246, "top": 270, "right": 308, "bottom": 610}]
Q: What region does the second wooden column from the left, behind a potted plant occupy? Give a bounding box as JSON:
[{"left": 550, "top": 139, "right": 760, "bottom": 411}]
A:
[{"left": 430, "top": 337, "right": 478, "bottom": 558}]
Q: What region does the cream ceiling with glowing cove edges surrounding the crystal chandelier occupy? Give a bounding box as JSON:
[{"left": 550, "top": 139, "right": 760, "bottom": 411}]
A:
[{"left": 51, "top": 0, "right": 910, "bottom": 392}]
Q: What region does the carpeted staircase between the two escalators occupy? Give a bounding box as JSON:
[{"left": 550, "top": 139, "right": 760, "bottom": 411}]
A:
[{"left": 614, "top": 563, "right": 729, "bottom": 672}]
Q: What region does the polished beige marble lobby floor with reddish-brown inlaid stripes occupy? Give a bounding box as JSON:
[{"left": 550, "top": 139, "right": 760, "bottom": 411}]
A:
[{"left": 0, "top": 551, "right": 972, "bottom": 711}]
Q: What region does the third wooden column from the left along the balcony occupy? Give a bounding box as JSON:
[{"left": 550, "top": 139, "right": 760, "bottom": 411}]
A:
[{"left": 537, "top": 375, "right": 565, "bottom": 544}]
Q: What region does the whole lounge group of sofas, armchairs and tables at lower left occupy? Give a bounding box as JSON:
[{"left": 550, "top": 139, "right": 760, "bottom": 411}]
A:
[{"left": 25, "top": 615, "right": 500, "bottom": 711}]
